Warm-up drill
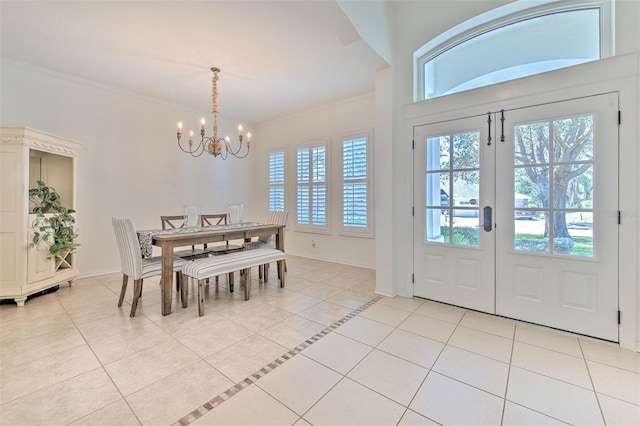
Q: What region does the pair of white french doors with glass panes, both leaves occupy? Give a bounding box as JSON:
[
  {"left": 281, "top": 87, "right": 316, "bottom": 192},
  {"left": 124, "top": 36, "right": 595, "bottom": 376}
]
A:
[{"left": 414, "top": 93, "right": 618, "bottom": 341}]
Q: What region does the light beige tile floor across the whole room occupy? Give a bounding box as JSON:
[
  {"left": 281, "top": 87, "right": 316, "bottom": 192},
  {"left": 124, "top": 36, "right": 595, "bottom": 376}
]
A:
[{"left": 0, "top": 256, "right": 640, "bottom": 426}]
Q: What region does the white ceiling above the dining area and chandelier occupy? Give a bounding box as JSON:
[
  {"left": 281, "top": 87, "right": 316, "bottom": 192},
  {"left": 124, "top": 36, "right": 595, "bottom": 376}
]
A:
[{"left": 0, "top": 0, "right": 396, "bottom": 123}]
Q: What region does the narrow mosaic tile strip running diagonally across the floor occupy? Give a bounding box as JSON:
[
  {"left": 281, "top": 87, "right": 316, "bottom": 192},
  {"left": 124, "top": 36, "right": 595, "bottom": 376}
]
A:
[{"left": 172, "top": 296, "right": 383, "bottom": 426}]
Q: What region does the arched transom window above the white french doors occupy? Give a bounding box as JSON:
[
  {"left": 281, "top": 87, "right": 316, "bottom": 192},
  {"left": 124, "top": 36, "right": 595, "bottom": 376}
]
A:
[{"left": 414, "top": 1, "right": 612, "bottom": 100}]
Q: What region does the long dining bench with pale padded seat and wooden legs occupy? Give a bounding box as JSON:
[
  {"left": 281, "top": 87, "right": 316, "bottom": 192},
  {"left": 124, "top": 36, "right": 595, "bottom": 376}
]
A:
[{"left": 182, "top": 248, "right": 284, "bottom": 316}]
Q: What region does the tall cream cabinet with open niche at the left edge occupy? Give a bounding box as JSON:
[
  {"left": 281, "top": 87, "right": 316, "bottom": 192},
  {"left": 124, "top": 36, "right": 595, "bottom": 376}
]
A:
[{"left": 0, "top": 127, "right": 80, "bottom": 306}]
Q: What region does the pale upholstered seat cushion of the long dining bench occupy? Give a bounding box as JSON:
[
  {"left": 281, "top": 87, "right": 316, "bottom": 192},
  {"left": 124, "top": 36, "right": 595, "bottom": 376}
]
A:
[{"left": 182, "top": 249, "right": 284, "bottom": 280}]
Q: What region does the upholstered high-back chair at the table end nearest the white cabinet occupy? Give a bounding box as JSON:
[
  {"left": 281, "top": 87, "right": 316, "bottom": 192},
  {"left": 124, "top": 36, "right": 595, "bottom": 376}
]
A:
[{"left": 111, "top": 217, "right": 188, "bottom": 317}]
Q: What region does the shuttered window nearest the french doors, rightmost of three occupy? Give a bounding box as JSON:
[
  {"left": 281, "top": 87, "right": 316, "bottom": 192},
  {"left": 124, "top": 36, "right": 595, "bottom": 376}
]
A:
[{"left": 341, "top": 134, "right": 372, "bottom": 235}]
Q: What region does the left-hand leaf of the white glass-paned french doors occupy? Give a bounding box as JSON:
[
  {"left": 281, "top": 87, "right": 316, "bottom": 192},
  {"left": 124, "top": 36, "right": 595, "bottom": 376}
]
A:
[{"left": 414, "top": 117, "right": 495, "bottom": 313}]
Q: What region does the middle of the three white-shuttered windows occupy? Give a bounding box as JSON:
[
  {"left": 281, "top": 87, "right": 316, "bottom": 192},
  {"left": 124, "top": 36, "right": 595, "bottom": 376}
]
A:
[{"left": 296, "top": 140, "right": 329, "bottom": 232}]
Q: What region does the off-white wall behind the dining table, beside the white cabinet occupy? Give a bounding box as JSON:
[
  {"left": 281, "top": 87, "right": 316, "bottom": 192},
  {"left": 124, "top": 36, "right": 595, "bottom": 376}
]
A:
[{"left": 0, "top": 60, "right": 251, "bottom": 276}]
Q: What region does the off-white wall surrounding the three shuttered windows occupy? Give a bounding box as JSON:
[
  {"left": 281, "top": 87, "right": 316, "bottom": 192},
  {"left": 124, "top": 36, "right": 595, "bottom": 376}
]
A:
[{"left": 252, "top": 94, "right": 377, "bottom": 268}]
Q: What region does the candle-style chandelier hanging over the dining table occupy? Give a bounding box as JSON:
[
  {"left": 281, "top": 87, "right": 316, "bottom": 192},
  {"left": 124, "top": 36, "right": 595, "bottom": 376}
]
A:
[{"left": 178, "top": 67, "right": 251, "bottom": 160}]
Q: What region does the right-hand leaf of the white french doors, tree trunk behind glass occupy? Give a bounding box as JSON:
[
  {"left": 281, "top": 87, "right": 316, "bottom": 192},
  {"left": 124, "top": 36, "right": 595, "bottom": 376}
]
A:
[{"left": 496, "top": 93, "right": 618, "bottom": 341}]
